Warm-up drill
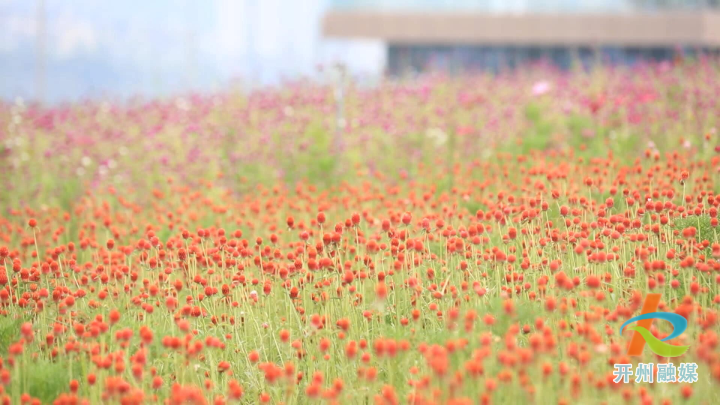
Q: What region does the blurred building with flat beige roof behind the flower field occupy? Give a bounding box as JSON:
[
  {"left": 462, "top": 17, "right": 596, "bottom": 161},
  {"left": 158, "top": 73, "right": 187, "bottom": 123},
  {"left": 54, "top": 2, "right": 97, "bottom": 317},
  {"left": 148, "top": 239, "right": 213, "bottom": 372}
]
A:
[{"left": 323, "top": 0, "right": 720, "bottom": 75}]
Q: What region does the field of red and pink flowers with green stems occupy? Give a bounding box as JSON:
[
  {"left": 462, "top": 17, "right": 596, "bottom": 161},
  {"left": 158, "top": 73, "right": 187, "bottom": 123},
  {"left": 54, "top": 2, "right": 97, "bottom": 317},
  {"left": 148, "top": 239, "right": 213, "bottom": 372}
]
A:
[{"left": 0, "top": 61, "right": 720, "bottom": 405}]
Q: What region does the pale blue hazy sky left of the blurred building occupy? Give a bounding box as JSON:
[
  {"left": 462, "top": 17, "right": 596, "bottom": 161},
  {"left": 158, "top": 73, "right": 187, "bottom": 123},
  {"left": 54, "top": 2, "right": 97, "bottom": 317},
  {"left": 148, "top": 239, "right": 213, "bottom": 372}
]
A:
[{"left": 0, "top": 0, "right": 385, "bottom": 101}]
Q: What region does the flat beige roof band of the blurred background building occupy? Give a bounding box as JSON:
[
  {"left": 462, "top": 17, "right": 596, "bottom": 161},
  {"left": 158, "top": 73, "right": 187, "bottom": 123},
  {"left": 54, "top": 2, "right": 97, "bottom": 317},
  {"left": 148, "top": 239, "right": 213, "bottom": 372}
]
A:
[{"left": 322, "top": 10, "right": 720, "bottom": 48}]
